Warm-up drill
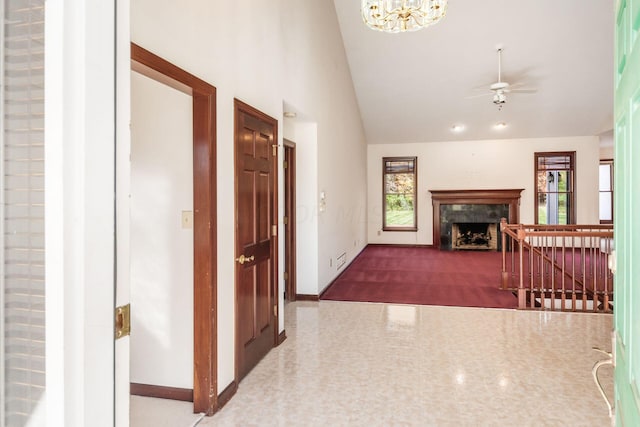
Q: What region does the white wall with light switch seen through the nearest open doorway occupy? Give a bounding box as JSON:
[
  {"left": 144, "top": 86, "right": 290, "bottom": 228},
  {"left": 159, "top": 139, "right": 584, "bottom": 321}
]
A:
[{"left": 130, "top": 72, "right": 193, "bottom": 389}]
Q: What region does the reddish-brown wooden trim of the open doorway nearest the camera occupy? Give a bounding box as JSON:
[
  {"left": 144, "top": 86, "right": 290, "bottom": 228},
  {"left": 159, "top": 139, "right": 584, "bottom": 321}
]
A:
[{"left": 131, "top": 43, "right": 218, "bottom": 415}]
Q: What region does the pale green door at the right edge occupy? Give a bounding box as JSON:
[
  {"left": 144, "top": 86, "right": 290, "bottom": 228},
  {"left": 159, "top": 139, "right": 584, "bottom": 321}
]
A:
[{"left": 614, "top": 0, "right": 640, "bottom": 426}]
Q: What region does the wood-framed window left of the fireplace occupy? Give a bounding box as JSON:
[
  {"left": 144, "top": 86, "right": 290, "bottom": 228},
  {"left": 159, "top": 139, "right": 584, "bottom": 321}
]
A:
[{"left": 382, "top": 157, "right": 418, "bottom": 231}]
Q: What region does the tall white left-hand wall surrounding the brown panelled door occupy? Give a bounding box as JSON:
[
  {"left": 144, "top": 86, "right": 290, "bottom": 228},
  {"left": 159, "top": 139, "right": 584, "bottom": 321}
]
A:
[{"left": 131, "top": 0, "right": 366, "bottom": 392}]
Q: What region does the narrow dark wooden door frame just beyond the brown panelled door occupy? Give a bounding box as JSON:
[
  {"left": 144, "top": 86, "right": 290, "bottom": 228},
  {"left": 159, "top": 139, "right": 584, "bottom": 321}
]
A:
[{"left": 283, "top": 139, "right": 298, "bottom": 301}]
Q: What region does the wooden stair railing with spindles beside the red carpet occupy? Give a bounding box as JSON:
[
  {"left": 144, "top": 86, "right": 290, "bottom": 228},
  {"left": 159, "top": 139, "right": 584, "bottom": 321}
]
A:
[{"left": 500, "top": 218, "right": 613, "bottom": 312}]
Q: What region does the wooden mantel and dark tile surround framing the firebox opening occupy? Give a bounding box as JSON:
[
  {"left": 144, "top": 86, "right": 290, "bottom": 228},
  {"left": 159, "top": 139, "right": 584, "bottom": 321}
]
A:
[{"left": 429, "top": 188, "right": 523, "bottom": 250}]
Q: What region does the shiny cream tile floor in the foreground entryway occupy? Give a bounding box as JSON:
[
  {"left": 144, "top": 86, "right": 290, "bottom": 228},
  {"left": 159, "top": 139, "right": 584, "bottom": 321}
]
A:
[{"left": 132, "top": 301, "right": 613, "bottom": 427}]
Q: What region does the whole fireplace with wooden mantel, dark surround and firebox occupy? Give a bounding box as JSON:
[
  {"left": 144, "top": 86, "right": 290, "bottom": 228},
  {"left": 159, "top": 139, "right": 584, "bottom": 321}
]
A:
[{"left": 430, "top": 189, "right": 522, "bottom": 251}]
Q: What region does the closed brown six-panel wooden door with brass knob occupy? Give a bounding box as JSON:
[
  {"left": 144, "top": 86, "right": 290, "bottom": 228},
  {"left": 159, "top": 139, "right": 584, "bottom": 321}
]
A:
[{"left": 235, "top": 100, "right": 278, "bottom": 380}]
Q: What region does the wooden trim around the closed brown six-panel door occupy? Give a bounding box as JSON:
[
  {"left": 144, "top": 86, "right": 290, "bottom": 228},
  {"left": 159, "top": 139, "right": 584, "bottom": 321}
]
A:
[{"left": 233, "top": 98, "right": 284, "bottom": 384}]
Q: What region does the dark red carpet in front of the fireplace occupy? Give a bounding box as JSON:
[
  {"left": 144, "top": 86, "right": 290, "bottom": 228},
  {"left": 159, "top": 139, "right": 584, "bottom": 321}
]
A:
[{"left": 321, "top": 246, "right": 518, "bottom": 308}]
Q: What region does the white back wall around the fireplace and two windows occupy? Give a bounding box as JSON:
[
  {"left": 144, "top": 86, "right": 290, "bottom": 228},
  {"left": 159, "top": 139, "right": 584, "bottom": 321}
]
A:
[{"left": 367, "top": 136, "right": 599, "bottom": 245}]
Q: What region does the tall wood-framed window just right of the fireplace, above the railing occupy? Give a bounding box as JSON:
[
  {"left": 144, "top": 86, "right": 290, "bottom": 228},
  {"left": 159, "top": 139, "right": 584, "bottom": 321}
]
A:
[{"left": 534, "top": 151, "right": 576, "bottom": 225}]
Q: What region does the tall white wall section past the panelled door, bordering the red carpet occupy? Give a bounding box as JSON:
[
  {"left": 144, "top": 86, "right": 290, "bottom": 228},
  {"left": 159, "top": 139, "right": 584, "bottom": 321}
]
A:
[{"left": 281, "top": 0, "right": 367, "bottom": 295}]
